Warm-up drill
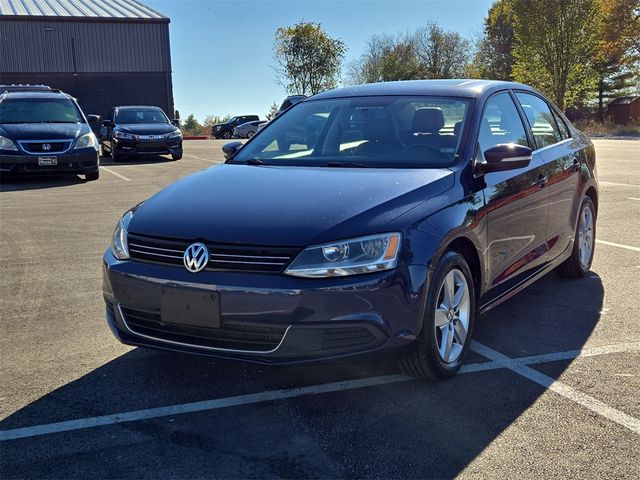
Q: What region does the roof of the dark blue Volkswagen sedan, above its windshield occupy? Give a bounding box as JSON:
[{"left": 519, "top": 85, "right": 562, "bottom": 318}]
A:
[{"left": 310, "top": 79, "right": 533, "bottom": 101}]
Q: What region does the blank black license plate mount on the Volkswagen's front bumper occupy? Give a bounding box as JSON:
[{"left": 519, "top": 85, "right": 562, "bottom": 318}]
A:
[{"left": 160, "top": 290, "right": 220, "bottom": 328}]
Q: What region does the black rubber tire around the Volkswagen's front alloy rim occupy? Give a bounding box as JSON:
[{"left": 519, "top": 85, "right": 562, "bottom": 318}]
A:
[{"left": 398, "top": 250, "right": 476, "bottom": 380}]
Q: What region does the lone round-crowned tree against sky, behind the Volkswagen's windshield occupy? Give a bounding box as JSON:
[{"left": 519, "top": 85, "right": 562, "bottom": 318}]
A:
[{"left": 274, "top": 22, "right": 346, "bottom": 95}]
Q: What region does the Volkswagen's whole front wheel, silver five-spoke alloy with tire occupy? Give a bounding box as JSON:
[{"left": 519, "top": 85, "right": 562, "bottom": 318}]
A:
[{"left": 399, "top": 251, "right": 476, "bottom": 380}]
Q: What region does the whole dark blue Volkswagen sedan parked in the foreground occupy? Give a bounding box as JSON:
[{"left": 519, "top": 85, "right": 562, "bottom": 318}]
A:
[{"left": 104, "top": 80, "right": 598, "bottom": 378}]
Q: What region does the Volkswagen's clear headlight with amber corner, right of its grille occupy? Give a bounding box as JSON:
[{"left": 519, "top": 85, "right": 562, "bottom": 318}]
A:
[{"left": 285, "top": 233, "right": 401, "bottom": 278}]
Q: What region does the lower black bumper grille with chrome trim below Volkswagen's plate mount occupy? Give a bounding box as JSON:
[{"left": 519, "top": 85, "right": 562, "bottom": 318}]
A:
[{"left": 120, "top": 306, "right": 287, "bottom": 353}]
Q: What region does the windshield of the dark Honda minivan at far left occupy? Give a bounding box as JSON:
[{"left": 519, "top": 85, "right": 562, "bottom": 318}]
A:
[{"left": 0, "top": 98, "right": 84, "bottom": 123}]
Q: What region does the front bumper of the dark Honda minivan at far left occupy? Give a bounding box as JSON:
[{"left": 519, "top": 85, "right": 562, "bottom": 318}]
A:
[{"left": 0, "top": 148, "right": 98, "bottom": 175}]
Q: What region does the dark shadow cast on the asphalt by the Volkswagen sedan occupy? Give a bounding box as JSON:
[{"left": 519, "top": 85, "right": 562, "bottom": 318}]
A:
[{"left": 0, "top": 273, "right": 604, "bottom": 478}]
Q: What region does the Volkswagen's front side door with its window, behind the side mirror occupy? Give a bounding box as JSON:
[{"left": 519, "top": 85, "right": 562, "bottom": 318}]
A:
[{"left": 476, "top": 91, "right": 548, "bottom": 304}]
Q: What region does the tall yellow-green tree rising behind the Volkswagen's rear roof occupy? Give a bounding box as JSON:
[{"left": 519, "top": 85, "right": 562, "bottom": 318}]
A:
[{"left": 513, "top": 0, "right": 598, "bottom": 109}]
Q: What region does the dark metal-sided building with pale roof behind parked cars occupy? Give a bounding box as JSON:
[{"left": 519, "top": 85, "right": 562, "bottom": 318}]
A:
[{"left": 0, "top": 0, "right": 174, "bottom": 122}]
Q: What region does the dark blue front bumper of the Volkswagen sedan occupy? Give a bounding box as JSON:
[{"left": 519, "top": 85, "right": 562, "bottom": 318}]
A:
[{"left": 103, "top": 249, "right": 427, "bottom": 364}]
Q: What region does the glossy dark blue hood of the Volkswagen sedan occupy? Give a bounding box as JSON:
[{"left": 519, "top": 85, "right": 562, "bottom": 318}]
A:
[{"left": 129, "top": 164, "right": 454, "bottom": 246}]
